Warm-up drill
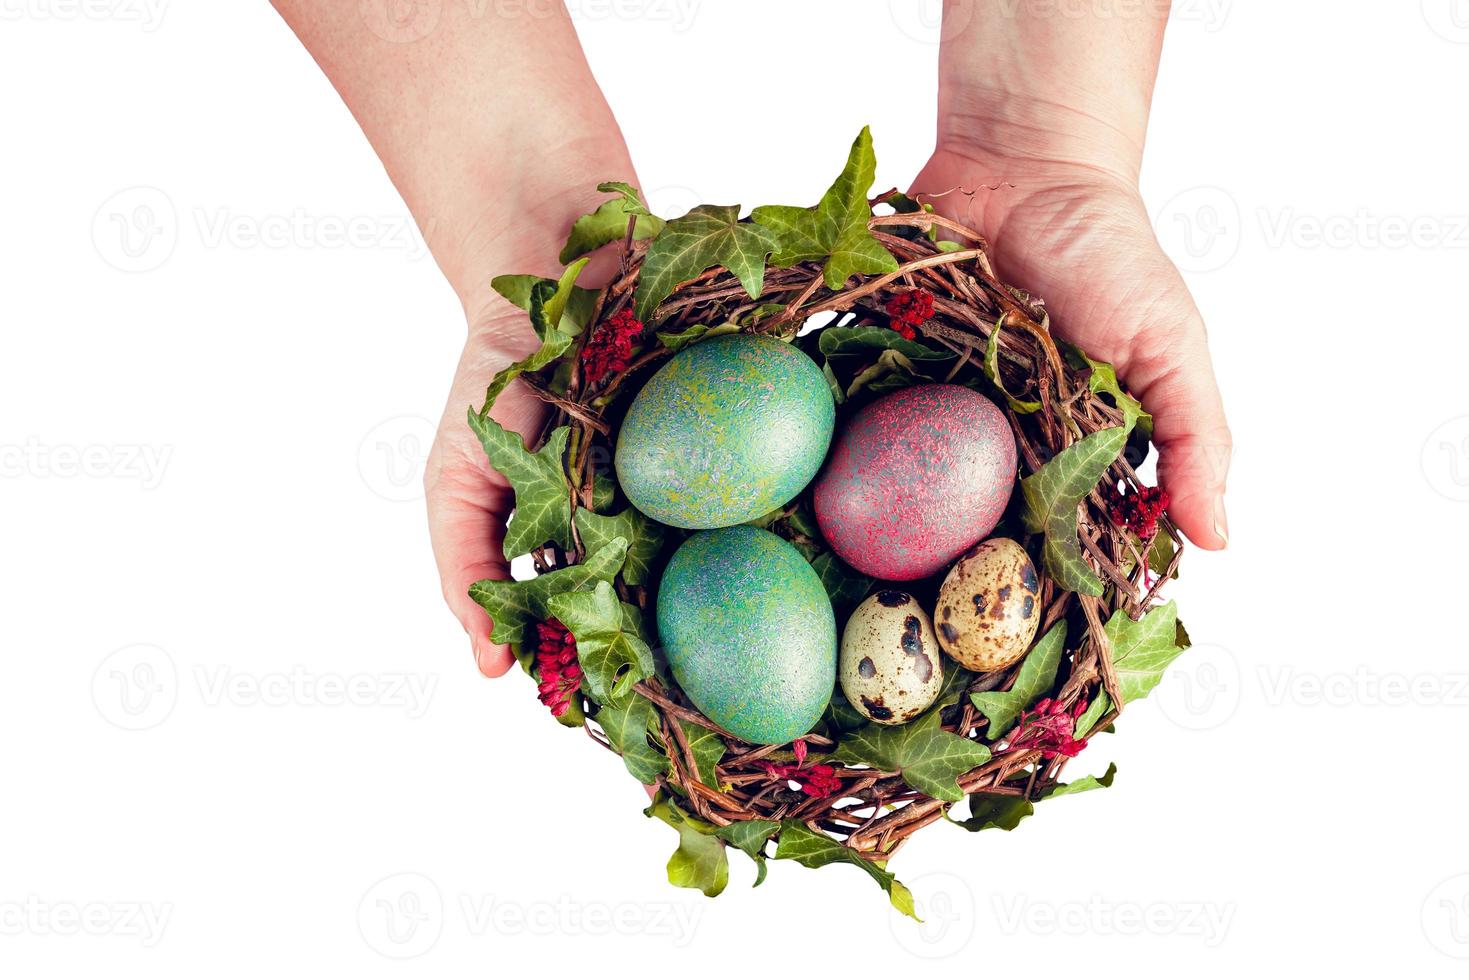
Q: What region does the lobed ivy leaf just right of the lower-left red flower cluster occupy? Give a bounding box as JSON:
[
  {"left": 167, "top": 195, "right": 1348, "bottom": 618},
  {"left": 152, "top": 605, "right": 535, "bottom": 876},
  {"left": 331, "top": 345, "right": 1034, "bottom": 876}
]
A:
[{"left": 546, "top": 582, "right": 654, "bottom": 704}]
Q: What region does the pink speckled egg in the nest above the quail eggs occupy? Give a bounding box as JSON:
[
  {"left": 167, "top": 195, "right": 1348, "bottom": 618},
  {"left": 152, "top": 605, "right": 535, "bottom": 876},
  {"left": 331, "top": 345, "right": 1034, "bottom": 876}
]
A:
[{"left": 815, "top": 385, "right": 1017, "bottom": 582}]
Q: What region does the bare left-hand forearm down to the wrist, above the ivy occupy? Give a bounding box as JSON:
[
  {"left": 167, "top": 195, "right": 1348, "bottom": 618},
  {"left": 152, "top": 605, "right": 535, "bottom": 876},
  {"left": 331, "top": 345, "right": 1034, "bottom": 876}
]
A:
[{"left": 273, "top": 0, "right": 632, "bottom": 312}]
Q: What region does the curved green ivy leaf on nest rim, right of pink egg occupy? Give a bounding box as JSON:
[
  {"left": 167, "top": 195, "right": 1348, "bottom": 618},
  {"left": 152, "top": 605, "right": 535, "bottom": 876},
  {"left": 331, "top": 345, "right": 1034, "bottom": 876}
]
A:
[{"left": 1019, "top": 426, "right": 1127, "bottom": 595}]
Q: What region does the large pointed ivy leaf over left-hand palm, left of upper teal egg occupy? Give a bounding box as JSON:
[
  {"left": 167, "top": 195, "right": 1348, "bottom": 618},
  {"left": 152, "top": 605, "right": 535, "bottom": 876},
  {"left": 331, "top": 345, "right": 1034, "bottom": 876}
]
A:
[{"left": 469, "top": 411, "right": 571, "bottom": 561}]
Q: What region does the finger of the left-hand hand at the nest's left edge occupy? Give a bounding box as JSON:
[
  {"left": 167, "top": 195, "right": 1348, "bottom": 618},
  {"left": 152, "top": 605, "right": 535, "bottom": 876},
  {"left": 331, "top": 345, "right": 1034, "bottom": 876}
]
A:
[{"left": 426, "top": 447, "right": 514, "bottom": 677}]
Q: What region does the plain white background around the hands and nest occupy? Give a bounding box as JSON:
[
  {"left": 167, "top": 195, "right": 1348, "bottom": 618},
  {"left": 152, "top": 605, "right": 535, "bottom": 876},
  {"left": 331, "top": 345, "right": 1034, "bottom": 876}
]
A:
[{"left": 0, "top": 0, "right": 1469, "bottom": 977}]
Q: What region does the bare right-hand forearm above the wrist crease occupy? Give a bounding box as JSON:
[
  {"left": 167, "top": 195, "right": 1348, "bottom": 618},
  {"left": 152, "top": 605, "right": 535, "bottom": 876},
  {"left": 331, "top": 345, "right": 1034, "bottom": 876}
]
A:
[{"left": 939, "top": 0, "right": 1169, "bottom": 181}]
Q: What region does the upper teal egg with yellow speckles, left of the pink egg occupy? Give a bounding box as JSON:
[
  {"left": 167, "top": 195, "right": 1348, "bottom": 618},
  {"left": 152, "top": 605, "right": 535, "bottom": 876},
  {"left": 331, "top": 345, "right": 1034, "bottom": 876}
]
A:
[{"left": 616, "top": 334, "right": 836, "bottom": 529}]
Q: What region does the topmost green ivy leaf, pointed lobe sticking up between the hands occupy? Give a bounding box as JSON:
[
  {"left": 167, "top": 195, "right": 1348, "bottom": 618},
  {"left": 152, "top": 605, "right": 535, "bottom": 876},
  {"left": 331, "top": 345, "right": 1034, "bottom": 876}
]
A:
[{"left": 751, "top": 126, "right": 898, "bottom": 289}]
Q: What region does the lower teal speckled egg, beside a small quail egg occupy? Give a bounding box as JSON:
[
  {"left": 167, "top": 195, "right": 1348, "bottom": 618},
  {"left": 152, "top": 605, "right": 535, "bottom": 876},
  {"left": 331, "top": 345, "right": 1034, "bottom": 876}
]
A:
[{"left": 658, "top": 526, "right": 836, "bottom": 745}]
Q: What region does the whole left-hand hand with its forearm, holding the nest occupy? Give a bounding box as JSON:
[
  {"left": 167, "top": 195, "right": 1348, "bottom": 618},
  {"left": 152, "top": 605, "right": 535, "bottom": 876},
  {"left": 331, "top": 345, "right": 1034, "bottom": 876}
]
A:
[{"left": 272, "top": 0, "right": 635, "bottom": 676}]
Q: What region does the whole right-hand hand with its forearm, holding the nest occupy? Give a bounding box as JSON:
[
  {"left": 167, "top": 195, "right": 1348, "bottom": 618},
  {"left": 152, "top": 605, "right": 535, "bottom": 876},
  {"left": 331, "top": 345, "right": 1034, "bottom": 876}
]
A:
[{"left": 914, "top": 0, "right": 1231, "bottom": 550}]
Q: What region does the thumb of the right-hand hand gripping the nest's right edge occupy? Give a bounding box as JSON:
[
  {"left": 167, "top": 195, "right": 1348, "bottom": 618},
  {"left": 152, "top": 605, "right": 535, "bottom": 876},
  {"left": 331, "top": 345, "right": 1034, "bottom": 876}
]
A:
[{"left": 1127, "top": 270, "right": 1234, "bottom": 551}]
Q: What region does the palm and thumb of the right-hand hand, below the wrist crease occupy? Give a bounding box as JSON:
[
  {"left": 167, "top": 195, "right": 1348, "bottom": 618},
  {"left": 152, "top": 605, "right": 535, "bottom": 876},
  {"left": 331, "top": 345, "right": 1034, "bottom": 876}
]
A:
[{"left": 914, "top": 148, "right": 1231, "bottom": 550}]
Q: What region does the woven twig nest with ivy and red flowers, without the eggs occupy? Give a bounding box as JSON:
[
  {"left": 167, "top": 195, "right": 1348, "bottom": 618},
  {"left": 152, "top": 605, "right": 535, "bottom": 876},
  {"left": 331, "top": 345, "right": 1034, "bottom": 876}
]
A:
[{"left": 472, "top": 150, "right": 1187, "bottom": 912}]
